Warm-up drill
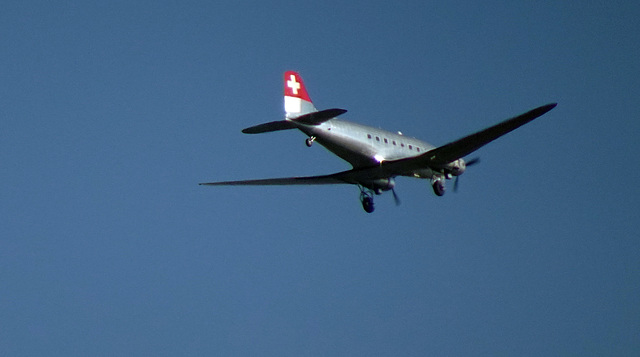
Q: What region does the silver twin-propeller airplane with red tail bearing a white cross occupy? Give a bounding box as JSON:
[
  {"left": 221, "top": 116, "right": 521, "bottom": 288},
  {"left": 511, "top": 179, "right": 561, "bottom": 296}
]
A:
[{"left": 200, "top": 71, "right": 557, "bottom": 213}]
